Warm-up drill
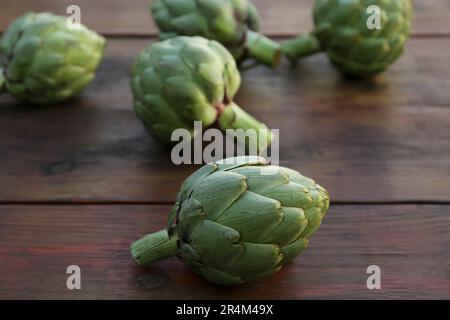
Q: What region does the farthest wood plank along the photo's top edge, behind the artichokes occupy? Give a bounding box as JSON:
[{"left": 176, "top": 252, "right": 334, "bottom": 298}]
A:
[{"left": 0, "top": 0, "right": 450, "bottom": 36}]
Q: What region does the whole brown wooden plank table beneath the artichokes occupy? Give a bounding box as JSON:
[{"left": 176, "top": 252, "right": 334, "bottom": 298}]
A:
[{"left": 0, "top": 0, "right": 450, "bottom": 299}]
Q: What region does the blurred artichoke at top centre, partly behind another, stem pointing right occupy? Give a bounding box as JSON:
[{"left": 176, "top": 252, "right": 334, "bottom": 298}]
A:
[{"left": 151, "top": 0, "right": 281, "bottom": 67}]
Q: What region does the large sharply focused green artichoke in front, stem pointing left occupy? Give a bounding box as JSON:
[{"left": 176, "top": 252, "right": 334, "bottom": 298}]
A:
[{"left": 131, "top": 156, "right": 329, "bottom": 285}]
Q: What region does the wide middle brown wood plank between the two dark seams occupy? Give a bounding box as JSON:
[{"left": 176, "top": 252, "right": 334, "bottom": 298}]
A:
[{"left": 0, "top": 39, "right": 450, "bottom": 203}]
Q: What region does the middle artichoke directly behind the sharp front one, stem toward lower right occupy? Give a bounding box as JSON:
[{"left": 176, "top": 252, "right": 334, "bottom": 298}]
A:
[{"left": 130, "top": 36, "right": 272, "bottom": 150}]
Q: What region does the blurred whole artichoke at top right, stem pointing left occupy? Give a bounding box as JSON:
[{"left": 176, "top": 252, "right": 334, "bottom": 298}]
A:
[{"left": 283, "top": 0, "right": 413, "bottom": 77}]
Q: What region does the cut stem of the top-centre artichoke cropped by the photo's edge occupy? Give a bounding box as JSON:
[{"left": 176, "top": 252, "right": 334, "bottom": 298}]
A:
[{"left": 246, "top": 30, "right": 282, "bottom": 68}]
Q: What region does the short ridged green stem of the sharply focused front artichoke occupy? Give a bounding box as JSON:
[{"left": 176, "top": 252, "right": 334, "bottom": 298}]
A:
[{"left": 131, "top": 229, "right": 179, "bottom": 265}]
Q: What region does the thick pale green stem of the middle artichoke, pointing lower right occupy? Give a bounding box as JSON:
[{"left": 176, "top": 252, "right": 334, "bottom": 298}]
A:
[{"left": 218, "top": 102, "right": 273, "bottom": 154}]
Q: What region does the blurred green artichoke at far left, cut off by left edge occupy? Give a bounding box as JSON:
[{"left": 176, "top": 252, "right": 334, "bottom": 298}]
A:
[{"left": 0, "top": 13, "right": 105, "bottom": 104}]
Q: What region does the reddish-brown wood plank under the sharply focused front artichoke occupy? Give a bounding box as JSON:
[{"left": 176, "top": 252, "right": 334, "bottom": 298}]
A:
[{"left": 0, "top": 205, "right": 450, "bottom": 299}]
